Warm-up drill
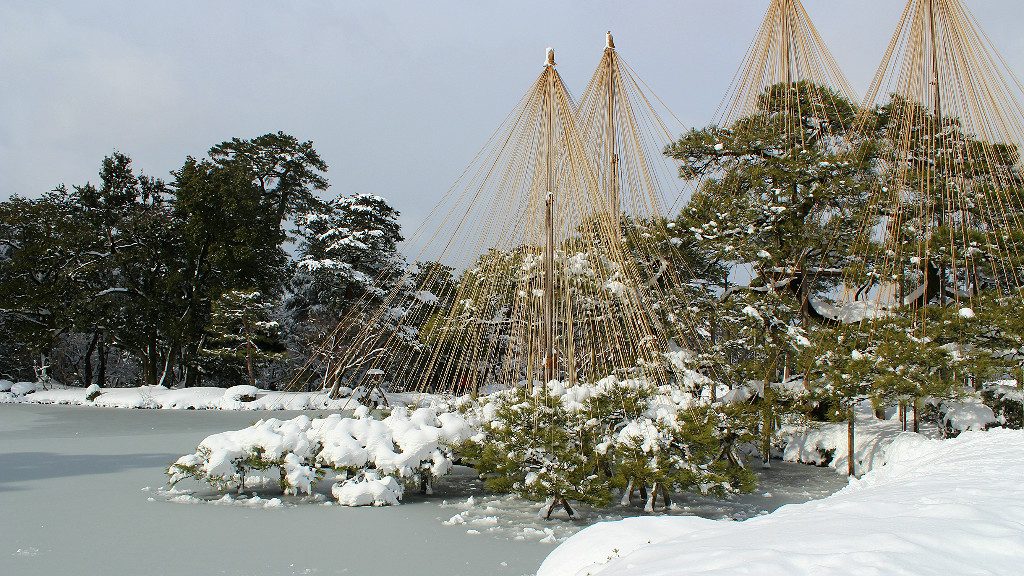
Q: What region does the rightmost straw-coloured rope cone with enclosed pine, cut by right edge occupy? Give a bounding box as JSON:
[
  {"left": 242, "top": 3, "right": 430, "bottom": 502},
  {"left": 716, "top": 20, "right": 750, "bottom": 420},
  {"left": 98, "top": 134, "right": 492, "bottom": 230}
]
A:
[{"left": 847, "top": 0, "right": 1024, "bottom": 333}]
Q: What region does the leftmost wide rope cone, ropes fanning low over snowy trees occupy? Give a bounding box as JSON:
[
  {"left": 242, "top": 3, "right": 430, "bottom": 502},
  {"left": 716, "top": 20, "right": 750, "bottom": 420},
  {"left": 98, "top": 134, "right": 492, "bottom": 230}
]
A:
[{"left": 293, "top": 43, "right": 692, "bottom": 393}]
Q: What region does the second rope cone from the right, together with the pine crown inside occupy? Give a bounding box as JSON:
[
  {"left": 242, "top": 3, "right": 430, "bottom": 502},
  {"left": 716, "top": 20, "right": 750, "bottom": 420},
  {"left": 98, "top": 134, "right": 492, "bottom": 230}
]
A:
[{"left": 667, "top": 0, "right": 870, "bottom": 322}]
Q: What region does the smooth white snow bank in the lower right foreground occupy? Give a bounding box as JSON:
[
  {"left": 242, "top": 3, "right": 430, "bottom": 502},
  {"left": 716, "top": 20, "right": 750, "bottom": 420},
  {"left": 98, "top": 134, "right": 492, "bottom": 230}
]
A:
[{"left": 538, "top": 428, "right": 1024, "bottom": 576}]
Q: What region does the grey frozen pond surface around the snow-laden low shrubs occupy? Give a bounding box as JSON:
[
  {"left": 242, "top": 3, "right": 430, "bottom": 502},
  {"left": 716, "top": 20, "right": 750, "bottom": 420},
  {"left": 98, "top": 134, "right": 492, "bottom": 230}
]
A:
[{"left": 0, "top": 405, "right": 846, "bottom": 576}]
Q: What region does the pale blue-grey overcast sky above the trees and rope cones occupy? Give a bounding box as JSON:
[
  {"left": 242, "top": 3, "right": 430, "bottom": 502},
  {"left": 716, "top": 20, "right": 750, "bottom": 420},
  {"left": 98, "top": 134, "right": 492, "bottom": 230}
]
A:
[{"left": 0, "top": 0, "right": 1024, "bottom": 233}]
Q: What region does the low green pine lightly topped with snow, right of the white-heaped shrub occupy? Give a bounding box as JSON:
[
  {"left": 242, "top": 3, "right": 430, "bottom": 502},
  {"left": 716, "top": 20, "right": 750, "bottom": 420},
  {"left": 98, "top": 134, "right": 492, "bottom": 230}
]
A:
[{"left": 461, "top": 376, "right": 754, "bottom": 517}]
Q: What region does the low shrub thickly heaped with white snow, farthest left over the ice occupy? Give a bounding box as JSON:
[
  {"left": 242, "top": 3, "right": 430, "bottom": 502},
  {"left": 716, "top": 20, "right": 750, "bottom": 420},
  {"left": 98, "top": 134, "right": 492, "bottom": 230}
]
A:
[{"left": 167, "top": 407, "right": 473, "bottom": 505}]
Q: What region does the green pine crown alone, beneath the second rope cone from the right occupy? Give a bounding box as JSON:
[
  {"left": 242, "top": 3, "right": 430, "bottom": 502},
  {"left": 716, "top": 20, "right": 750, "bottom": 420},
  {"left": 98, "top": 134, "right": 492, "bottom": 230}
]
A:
[{"left": 666, "top": 83, "right": 878, "bottom": 320}]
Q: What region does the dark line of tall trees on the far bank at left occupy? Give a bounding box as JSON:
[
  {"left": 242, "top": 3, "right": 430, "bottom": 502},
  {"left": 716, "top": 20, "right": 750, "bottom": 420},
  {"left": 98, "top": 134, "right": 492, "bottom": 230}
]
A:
[{"left": 0, "top": 132, "right": 411, "bottom": 387}]
